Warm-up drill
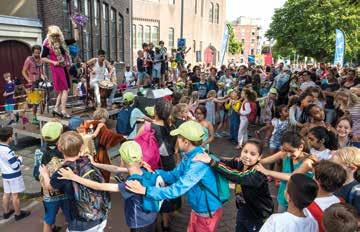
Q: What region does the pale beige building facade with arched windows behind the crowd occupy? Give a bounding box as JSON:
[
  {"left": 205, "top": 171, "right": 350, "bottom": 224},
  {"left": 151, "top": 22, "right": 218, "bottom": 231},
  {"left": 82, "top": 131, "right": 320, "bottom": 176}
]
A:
[{"left": 132, "top": 0, "right": 226, "bottom": 65}]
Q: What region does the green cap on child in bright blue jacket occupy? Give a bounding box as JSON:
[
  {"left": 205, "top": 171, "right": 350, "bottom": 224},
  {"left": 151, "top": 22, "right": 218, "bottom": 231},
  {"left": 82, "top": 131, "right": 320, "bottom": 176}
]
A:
[{"left": 170, "top": 121, "right": 204, "bottom": 142}]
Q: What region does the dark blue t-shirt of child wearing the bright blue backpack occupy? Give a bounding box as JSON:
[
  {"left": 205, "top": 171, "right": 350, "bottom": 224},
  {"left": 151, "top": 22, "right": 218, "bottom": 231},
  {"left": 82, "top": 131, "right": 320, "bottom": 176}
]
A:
[{"left": 118, "top": 172, "right": 157, "bottom": 229}]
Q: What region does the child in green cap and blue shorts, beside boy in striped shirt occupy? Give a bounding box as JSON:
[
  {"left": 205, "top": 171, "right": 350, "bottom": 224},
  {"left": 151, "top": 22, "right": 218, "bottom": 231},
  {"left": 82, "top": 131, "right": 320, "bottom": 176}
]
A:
[{"left": 34, "top": 122, "right": 70, "bottom": 232}]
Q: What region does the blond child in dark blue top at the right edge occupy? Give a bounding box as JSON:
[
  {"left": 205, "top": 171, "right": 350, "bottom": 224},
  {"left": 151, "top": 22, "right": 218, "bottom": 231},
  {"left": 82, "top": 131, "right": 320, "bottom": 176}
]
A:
[{"left": 331, "top": 147, "right": 360, "bottom": 215}]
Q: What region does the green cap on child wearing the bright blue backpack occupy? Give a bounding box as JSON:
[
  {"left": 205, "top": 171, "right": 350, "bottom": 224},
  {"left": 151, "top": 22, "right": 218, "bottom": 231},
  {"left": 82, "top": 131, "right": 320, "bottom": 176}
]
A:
[{"left": 119, "top": 141, "right": 142, "bottom": 163}]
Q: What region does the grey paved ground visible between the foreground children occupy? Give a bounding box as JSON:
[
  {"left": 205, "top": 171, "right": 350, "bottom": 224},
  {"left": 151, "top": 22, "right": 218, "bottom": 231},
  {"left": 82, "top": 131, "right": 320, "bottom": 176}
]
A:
[{"left": 0, "top": 134, "right": 243, "bottom": 232}]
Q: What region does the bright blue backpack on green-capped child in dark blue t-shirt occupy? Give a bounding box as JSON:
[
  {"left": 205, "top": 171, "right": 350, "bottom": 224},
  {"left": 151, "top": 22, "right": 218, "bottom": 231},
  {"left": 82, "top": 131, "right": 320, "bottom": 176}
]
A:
[{"left": 128, "top": 169, "right": 165, "bottom": 212}]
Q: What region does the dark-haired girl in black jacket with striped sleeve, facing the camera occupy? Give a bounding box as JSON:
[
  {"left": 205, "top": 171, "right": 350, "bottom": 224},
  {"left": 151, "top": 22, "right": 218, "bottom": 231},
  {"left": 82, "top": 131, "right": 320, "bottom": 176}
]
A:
[{"left": 193, "top": 139, "right": 274, "bottom": 232}]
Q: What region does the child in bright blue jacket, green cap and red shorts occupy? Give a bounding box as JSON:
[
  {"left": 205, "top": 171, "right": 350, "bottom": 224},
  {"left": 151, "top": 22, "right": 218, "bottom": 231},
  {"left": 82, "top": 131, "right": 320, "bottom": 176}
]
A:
[{"left": 126, "top": 121, "right": 224, "bottom": 232}]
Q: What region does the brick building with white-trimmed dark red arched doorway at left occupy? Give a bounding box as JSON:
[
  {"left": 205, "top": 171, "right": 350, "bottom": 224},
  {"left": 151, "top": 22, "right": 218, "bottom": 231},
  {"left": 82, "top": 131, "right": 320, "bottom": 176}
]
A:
[{"left": 0, "top": 0, "right": 132, "bottom": 95}]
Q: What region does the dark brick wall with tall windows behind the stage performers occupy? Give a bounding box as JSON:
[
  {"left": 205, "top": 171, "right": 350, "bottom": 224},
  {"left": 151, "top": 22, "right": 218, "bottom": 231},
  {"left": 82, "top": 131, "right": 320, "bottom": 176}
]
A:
[{"left": 37, "top": 0, "right": 131, "bottom": 64}]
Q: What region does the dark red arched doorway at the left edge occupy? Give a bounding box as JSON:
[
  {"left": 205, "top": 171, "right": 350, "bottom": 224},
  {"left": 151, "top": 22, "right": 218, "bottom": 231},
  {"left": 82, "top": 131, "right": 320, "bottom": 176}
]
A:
[{"left": 0, "top": 40, "right": 31, "bottom": 105}]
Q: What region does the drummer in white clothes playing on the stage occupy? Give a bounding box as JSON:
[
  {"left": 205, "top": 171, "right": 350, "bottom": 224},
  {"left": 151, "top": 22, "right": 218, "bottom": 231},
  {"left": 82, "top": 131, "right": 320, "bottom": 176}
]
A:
[{"left": 87, "top": 49, "right": 110, "bottom": 106}]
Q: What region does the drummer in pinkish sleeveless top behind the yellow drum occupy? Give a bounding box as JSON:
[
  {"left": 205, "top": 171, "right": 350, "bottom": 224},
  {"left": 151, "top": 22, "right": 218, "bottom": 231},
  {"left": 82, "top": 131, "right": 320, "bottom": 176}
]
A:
[{"left": 22, "top": 45, "right": 44, "bottom": 124}]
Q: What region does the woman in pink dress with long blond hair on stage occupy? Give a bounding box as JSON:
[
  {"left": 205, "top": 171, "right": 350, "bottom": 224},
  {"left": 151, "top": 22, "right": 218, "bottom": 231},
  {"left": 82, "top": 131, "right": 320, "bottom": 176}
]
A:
[{"left": 41, "top": 26, "right": 71, "bottom": 118}]
